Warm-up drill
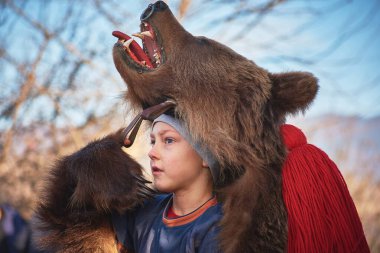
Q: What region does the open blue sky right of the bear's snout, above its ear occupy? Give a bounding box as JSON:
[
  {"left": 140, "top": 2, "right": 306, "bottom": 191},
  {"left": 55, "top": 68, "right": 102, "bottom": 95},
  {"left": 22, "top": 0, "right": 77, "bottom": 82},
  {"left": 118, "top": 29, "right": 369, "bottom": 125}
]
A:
[{"left": 180, "top": 0, "right": 380, "bottom": 118}]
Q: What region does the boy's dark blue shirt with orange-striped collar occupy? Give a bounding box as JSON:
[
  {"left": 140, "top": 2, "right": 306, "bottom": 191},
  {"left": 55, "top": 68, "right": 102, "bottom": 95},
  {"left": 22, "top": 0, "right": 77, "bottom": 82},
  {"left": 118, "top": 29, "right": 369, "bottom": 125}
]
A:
[{"left": 112, "top": 194, "right": 222, "bottom": 253}]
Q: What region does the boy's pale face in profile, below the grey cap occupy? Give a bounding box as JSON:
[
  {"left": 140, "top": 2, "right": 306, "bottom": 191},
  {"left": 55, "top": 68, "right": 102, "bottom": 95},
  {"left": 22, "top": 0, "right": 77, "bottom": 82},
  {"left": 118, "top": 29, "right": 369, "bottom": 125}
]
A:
[{"left": 148, "top": 122, "right": 210, "bottom": 193}]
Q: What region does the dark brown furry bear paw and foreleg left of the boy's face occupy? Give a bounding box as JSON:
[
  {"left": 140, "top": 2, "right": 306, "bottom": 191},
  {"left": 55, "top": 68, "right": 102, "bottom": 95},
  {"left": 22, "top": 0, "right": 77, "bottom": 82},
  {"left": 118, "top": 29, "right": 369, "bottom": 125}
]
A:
[{"left": 34, "top": 131, "right": 152, "bottom": 253}]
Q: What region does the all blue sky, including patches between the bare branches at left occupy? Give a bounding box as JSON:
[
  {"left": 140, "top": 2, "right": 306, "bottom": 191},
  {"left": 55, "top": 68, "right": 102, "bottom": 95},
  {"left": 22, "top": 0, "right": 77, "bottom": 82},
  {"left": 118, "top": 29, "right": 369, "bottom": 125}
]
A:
[{"left": 0, "top": 0, "right": 380, "bottom": 131}]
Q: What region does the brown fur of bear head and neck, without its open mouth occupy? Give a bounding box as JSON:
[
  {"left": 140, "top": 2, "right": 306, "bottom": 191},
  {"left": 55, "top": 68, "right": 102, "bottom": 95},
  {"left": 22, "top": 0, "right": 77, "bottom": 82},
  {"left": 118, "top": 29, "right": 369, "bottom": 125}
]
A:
[{"left": 113, "top": 2, "right": 318, "bottom": 253}]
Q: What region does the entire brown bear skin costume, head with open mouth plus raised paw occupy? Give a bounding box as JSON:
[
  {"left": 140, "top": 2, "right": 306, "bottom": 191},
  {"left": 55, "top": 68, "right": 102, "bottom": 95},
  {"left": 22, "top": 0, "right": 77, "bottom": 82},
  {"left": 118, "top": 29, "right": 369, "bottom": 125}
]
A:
[{"left": 35, "top": 1, "right": 318, "bottom": 253}]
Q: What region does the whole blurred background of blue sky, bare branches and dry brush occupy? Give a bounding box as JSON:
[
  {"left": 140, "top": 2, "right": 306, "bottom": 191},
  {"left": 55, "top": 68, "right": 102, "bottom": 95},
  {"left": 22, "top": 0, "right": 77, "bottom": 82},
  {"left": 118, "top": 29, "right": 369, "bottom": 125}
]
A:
[{"left": 0, "top": 0, "right": 380, "bottom": 252}]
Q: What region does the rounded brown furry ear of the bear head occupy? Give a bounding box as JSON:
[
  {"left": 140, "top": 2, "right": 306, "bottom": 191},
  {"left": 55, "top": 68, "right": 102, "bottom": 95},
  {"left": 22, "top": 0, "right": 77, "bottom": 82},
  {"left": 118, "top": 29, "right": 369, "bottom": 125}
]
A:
[{"left": 269, "top": 72, "right": 318, "bottom": 115}]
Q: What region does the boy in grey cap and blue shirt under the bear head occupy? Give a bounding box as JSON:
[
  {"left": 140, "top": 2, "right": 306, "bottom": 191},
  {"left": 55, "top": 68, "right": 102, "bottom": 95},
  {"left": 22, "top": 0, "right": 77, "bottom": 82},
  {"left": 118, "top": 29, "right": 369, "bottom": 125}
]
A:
[{"left": 113, "top": 114, "right": 222, "bottom": 253}]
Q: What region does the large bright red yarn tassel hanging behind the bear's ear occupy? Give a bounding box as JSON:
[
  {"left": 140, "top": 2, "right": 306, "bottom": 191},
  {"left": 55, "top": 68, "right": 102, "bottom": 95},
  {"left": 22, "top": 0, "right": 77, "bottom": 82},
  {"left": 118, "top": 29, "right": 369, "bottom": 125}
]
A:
[{"left": 281, "top": 125, "right": 369, "bottom": 253}]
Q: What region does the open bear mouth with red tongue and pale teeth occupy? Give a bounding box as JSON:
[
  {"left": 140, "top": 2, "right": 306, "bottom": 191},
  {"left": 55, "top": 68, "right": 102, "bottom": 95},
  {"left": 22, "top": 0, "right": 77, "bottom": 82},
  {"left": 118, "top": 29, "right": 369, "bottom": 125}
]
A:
[{"left": 112, "top": 21, "right": 164, "bottom": 69}]
